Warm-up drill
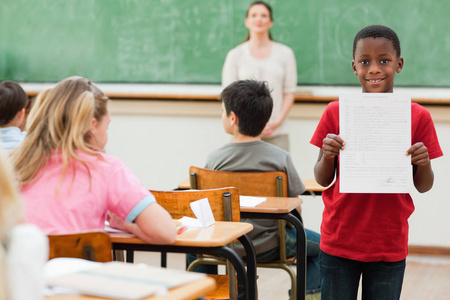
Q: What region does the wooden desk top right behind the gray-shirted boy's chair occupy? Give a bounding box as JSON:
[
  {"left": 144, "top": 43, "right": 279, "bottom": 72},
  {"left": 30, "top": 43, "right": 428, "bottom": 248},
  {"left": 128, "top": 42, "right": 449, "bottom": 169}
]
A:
[{"left": 241, "top": 197, "right": 303, "bottom": 214}]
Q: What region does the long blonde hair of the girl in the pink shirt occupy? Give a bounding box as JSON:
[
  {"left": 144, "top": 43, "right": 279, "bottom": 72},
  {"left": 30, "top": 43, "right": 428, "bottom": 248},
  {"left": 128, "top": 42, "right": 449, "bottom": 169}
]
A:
[{"left": 11, "top": 76, "right": 108, "bottom": 186}]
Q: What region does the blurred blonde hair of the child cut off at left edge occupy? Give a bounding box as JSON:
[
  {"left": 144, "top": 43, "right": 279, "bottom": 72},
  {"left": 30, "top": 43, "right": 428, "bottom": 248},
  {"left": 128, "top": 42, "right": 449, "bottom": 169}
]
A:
[{"left": 0, "top": 148, "right": 21, "bottom": 300}]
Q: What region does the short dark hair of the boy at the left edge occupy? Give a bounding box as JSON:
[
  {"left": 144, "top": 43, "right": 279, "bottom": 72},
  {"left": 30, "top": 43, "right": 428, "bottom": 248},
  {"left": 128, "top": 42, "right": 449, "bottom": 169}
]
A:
[{"left": 0, "top": 81, "right": 29, "bottom": 126}]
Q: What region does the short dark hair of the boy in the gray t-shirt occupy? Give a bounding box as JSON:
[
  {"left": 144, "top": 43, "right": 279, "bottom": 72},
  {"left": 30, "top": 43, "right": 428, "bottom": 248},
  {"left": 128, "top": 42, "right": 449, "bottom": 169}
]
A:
[{"left": 220, "top": 80, "right": 273, "bottom": 137}]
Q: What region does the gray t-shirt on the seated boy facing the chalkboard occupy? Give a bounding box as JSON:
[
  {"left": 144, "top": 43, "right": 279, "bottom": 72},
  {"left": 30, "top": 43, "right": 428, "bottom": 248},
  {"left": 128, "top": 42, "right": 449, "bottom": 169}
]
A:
[{"left": 205, "top": 141, "right": 306, "bottom": 256}]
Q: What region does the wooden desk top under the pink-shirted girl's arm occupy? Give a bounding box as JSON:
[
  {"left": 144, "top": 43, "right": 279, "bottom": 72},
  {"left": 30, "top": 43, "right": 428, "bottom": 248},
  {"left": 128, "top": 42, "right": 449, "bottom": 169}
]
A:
[{"left": 109, "top": 221, "right": 253, "bottom": 247}]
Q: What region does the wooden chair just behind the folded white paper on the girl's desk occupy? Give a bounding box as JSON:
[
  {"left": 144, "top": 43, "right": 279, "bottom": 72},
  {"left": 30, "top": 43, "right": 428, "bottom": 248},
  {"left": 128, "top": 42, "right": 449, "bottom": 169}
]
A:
[{"left": 150, "top": 187, "right": 241, "bottom": 299}]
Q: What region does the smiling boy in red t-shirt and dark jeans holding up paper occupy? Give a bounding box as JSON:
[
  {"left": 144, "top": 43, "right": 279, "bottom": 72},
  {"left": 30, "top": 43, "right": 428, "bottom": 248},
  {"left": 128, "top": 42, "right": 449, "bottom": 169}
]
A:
[{"left": 311, "top": 25, "right": 443, "bottom": 300}]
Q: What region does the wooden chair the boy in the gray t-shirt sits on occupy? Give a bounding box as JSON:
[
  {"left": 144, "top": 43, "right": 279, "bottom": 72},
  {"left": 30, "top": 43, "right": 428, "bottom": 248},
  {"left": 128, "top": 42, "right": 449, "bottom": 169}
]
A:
[{"left": 189, "top": 166, "right": 297, "bottom": 299}]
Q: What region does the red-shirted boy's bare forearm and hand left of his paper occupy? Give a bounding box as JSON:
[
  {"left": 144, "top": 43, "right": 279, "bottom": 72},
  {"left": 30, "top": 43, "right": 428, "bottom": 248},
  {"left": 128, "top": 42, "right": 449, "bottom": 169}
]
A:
[{"left": 314, "top": 133, "right": 345, "bottom": 186}]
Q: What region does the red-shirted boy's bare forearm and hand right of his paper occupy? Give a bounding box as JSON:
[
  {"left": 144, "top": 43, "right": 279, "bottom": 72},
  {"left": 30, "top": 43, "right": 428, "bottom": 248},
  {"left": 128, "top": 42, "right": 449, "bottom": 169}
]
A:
[{"left": 406, "top": 142, "right": 434, "bottom": 193}]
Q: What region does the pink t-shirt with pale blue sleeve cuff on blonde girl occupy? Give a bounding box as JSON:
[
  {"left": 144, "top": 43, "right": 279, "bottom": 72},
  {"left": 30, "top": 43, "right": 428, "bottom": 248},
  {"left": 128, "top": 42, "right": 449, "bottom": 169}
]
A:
[{"left": 21, "top": 151, "right": 156, "bottom": 234}]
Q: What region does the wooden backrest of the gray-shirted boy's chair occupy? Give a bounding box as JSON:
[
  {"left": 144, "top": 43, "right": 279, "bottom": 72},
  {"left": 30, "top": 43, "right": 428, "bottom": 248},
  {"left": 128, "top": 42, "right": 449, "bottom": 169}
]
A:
[{"left": 189, "top": 167, "right": 287, "bottom": 197}]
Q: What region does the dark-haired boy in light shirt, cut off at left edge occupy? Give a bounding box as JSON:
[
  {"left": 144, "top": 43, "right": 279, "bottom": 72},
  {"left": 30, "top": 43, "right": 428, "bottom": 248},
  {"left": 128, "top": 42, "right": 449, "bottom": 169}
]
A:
[{"left": 0, "top": 81, "right": 30, "bottom": 153}]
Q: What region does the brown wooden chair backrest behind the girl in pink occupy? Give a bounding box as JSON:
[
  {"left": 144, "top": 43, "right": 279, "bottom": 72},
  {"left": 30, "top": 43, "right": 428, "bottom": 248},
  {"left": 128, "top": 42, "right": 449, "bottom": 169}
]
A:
[{"left": 48, "top": 231, "right": 112, "bottom": 262}]
